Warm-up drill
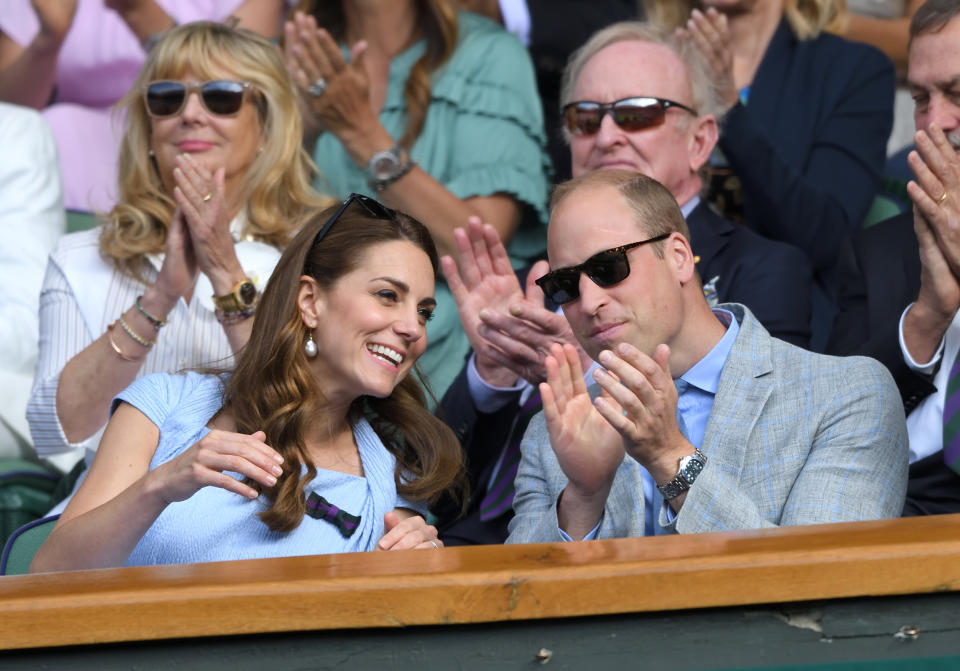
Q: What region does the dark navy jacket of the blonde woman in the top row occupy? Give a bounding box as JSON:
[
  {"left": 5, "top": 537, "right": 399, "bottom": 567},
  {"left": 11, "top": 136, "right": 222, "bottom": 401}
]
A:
[{"left": 720, "top": 20, "right": 895, "bottom": 273}]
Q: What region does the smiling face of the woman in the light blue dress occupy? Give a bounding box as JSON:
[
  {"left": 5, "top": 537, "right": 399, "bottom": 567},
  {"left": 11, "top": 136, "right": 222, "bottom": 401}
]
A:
[{"left": 311, "top": 240, "right": 436, "bottom": 402}]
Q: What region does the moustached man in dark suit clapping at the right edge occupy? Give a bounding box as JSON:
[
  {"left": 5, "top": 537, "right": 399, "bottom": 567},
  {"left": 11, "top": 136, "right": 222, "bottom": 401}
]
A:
[{"left": 829, "top": 0, "right": 960, "bottom": 515}]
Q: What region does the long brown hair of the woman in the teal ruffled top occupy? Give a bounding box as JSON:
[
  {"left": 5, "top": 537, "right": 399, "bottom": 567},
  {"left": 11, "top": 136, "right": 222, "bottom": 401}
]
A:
[{"left": 296, "top": 0, "right": 457, "bottom": 151}]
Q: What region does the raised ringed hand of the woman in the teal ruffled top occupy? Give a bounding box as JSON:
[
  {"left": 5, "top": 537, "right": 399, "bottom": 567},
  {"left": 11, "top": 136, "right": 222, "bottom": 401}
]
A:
[{"left": 284, "top": 12, "right": 380, "bottom": 164}]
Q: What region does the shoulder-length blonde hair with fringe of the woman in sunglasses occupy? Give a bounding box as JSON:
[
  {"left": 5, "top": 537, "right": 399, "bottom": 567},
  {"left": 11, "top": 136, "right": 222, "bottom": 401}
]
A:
[{"left": 100, "top": 21, "right": 330, "bottom": 276}]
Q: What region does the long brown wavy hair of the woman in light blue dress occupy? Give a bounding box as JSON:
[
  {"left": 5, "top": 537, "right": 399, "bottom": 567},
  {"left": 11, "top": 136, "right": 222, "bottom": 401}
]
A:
[{"left": 224, "top": 198, "right": 462, "bottom": 531}]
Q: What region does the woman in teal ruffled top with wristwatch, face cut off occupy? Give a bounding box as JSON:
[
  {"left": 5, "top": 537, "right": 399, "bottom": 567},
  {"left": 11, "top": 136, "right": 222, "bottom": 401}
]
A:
[{"left": 284, "top": 0, "right": 549, "bottom": 395}]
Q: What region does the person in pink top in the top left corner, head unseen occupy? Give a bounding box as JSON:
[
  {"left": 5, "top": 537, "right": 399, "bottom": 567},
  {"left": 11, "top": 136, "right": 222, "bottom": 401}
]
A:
[{"left": 0, "top": 0, "right": 285, "bottom": 211}]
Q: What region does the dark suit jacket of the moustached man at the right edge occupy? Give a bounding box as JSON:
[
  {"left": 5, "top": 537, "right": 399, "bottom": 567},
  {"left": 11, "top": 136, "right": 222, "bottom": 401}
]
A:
[{"left": 828, "top": 212, "right": 960, "bottom": 515}]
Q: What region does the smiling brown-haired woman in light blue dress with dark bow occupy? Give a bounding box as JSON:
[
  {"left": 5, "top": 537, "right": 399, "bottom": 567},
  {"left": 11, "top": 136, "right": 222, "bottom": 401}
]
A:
[{"left": 31, "top": 194, "right": 461, "bottom": 571}]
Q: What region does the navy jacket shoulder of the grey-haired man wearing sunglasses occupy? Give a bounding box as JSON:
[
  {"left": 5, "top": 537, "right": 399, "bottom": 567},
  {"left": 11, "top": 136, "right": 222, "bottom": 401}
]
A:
[{"left": 687, "top": 202, "right": 813, "bottom": 347}]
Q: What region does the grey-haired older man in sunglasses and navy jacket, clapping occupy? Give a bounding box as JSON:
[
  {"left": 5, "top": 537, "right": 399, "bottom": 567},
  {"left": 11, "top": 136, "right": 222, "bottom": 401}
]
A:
[{"left": 435, "top": 23, "right": 812, "bottom": 544}]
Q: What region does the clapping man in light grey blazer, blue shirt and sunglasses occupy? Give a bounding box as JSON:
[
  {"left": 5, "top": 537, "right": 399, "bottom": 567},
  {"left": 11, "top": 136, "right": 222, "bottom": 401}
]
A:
[{"left": 507, "top": 170, "right": 907, "bottom": 543}]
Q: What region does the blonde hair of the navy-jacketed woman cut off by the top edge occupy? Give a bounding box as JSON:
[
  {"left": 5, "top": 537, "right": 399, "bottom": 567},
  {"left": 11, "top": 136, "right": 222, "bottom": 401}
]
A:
[{"left": 643, "top": 0, "right": 847, "bottom": 40}]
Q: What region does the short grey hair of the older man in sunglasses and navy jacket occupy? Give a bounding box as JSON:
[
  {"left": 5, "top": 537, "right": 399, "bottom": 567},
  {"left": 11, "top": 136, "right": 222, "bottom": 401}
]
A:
[{"left": 560, "top": 21, "right": 725, "bottom": 123}]
